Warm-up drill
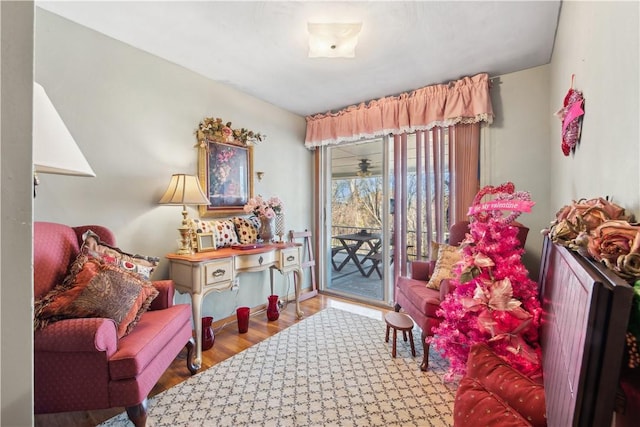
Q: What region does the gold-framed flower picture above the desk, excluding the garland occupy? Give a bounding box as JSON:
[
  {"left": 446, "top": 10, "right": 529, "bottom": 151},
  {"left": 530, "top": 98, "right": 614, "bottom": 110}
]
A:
[{"left": 198, "top": 140, "right": 253, "bottom": 217}]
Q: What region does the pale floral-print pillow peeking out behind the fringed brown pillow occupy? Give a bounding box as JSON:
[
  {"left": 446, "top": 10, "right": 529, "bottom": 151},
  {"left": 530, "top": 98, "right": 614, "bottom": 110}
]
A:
[{"left": 80, "top": 230, "right": 160, "bottom": 280}]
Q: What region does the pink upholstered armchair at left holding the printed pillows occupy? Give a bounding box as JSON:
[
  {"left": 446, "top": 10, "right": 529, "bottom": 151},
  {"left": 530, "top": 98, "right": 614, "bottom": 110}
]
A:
[{"left": 34, "top": 222, "right": 197, "bottom": 427}]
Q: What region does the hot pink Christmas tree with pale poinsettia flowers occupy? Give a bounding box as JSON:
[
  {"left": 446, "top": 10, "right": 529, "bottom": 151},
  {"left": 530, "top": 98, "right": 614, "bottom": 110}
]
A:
[{"left": 429, "top": 183, "right": 542, "bottom": 379}]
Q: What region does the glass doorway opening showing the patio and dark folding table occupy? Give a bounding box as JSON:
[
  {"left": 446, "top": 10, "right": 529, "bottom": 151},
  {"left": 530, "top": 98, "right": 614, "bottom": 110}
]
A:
[{"left": 321, "top": 138, "right": 393, "bottom": 304}]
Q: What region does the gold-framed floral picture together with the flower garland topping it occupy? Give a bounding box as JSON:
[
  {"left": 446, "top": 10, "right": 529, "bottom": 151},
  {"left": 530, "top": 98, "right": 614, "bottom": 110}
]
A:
[{"left": 195, "top": 117, "right": 265, "bottom": 217}]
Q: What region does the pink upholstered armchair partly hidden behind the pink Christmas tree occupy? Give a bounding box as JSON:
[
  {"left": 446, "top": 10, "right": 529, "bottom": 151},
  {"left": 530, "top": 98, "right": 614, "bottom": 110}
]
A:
[{"left": 395, "top": 221, "right": 529, "bottom": 371}]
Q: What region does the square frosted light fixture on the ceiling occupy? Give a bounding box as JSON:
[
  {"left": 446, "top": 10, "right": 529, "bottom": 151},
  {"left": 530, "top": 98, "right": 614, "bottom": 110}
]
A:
[{"left": 307, "top": 22, "right": 362, "bottom": 58}]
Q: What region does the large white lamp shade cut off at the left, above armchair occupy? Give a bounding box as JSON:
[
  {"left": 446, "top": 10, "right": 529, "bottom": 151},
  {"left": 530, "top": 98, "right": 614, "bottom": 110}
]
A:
[{"left": 33, "top": 82, "right": 96, "bottom": 176}]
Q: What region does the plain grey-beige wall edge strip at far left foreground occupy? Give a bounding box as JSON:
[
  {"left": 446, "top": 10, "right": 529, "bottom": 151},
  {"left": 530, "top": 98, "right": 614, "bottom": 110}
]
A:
[{"left": 0, "top": 1, "right": 33, "bottom": 427}]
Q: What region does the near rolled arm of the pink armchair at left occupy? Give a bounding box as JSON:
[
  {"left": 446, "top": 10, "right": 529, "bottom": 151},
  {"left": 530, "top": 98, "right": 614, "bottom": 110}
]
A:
[{"left": 33, "top": 318, "right": 118, "bottom": 358}]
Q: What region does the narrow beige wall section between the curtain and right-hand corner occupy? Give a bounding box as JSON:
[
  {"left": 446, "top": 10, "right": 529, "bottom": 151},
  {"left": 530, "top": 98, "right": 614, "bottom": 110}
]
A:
[{"left": 481, "top": 66, "right": 551, "bottom": 280}]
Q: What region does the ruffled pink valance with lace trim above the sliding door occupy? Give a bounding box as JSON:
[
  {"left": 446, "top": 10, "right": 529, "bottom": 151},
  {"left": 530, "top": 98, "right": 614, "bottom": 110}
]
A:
[{"left": 305, "top": 73, "right": 493, "bottom": 148}]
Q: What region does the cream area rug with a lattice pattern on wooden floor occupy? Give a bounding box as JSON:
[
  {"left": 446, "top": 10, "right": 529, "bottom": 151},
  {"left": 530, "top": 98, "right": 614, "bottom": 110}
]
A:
[{"left": 101, "top": 308, "right": 457, "bottom": 427}]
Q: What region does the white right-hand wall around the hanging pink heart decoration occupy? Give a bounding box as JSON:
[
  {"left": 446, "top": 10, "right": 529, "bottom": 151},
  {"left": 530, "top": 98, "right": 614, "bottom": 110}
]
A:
[{"left": 549, "top": 1, "right": 640, "bottom": 217}]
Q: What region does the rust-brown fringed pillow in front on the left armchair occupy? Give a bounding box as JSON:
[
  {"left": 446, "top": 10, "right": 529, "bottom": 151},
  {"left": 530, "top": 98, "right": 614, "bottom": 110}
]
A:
[{"left": 34, "top": 253, "right": 158, "bottom": 338}]
